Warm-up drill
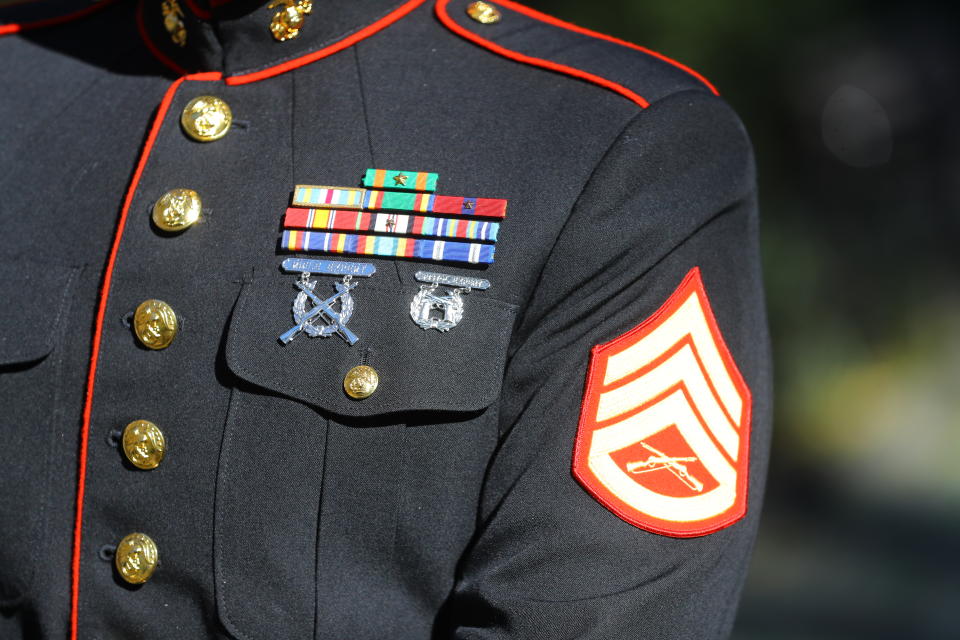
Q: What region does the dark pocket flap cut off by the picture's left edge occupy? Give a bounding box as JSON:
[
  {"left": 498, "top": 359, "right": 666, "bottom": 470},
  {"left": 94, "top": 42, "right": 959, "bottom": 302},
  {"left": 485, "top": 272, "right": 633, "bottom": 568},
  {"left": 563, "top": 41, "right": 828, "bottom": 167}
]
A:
[{"left": 0, "top": 261, "right": 77, "bottom": 366}]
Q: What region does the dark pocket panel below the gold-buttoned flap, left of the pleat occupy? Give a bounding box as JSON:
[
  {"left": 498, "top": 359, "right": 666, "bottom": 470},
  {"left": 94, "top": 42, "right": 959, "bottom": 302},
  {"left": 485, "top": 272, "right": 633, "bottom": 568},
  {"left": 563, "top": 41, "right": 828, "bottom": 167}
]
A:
[{"left": 214, "top": 387, "right": 327, "bottom": 638}]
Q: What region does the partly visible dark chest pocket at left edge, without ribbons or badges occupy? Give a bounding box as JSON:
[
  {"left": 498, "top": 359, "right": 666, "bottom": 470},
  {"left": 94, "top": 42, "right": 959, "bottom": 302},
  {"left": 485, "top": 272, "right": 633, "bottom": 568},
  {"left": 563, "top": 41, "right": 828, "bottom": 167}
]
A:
[{"left": 0, "top": 262, "right": 78, "bottom": 605}]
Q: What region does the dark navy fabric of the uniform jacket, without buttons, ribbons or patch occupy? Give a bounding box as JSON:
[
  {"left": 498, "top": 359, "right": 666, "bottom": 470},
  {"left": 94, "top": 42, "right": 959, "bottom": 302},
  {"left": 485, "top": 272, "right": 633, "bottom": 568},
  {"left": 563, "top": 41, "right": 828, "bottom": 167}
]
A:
[{"left": 0, "top": 0, "right": 771, "bottom": 640}]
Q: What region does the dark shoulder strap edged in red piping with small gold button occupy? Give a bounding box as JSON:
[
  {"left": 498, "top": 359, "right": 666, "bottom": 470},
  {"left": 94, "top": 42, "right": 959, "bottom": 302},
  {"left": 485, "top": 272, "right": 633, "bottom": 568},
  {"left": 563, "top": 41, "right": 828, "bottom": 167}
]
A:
[{"left": 435, "top": 0, "right": 717, "bottom": 107}]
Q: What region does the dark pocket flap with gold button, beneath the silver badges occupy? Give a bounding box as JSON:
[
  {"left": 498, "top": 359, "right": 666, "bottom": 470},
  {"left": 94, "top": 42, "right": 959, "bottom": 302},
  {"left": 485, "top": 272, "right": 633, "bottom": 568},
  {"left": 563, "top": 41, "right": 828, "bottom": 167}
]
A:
[{"left": 226, "top": 275, "right": 516, "bottom": 417}]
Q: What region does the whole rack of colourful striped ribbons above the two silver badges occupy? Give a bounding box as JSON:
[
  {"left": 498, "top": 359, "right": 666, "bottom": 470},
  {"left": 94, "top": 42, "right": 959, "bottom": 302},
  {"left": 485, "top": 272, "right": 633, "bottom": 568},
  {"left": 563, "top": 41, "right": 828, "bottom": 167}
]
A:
[{"left": 280, "top": 169, "right": 507, "bottom": 265}]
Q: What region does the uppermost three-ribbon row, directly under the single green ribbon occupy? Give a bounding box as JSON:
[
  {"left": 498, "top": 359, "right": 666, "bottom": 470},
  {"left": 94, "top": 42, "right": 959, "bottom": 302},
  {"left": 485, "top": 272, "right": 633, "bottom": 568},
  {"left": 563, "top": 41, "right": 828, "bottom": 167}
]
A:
[{"left": 293, "top": 185, "right": 507, "bottom": 218}]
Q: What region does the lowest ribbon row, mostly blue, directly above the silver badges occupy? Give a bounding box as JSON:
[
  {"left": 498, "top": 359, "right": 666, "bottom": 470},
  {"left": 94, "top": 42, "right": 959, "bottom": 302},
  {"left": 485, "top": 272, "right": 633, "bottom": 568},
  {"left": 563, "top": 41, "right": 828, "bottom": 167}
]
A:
[{"left": 280, "top": 231, "right": 494, "bottom": 264}]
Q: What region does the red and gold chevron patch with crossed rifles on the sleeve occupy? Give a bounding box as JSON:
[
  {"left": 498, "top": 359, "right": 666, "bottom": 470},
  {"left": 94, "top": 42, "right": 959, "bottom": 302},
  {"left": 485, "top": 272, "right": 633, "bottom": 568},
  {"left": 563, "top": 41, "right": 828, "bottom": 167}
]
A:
[{"left": 573, "top": 268, "right": 751, "bottom": 537}]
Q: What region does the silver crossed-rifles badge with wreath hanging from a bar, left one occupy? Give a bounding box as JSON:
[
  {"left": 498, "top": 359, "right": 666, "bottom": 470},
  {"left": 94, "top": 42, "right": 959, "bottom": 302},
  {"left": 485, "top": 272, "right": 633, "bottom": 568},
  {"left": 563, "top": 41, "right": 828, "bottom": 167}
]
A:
[{"left": 280, "top": 258, "right": 377, "bottom": 345}]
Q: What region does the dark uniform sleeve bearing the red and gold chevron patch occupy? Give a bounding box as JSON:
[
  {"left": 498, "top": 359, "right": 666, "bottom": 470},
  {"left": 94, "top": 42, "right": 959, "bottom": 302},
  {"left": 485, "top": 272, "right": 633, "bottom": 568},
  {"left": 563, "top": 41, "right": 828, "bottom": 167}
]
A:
[{"left": 445, "top": 91, "right": 771, "bottom": 640}]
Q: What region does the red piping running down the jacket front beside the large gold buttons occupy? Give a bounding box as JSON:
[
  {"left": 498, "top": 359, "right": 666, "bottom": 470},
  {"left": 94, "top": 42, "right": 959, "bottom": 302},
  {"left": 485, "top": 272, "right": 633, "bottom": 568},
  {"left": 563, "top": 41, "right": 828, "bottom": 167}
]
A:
[{"left": 70, "top": 71, "right": 222, "bottom": 640}]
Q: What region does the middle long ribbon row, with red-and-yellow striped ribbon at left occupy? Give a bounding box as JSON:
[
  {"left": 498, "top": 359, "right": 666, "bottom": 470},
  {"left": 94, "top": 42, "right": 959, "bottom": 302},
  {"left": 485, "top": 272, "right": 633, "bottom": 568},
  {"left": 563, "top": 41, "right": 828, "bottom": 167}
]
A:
[{"left": 283, "top": 207, "right": 500, "bottom": 242}]
